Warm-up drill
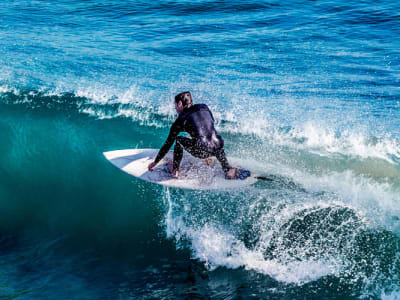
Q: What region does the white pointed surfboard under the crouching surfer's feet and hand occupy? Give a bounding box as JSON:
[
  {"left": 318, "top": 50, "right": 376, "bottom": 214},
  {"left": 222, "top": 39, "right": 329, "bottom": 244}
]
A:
[{"left": 103, "top": 149, "right": 257, "bottom": 190}]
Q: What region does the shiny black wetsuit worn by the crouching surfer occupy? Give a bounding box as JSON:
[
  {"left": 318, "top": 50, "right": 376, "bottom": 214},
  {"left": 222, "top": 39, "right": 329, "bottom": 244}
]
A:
[{"left": 154, "top": 104, "right": 231, "bottom": 173}]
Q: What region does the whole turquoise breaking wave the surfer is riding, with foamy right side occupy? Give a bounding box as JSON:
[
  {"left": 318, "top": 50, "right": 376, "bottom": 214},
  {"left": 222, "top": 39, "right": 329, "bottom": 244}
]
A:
[{"left": 0, "top": 90, "right": 400, "bottom": 297}]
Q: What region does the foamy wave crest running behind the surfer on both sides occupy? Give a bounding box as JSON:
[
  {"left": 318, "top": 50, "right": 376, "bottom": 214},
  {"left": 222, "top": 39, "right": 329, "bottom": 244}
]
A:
[{"left": 0, "top": 85, "right": 400, "bottom": 166}]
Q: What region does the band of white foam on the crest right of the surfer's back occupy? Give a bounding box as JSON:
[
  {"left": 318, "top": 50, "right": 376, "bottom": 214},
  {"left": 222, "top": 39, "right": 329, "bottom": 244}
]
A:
[{"left": 218, "top": 117, "right": 400, "bottom": 164}]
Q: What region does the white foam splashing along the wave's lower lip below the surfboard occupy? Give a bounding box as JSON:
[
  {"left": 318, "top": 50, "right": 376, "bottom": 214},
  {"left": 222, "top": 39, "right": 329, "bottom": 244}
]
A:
[{"left": 165, "top": 190, "right": 342, "bottom": 285}]
